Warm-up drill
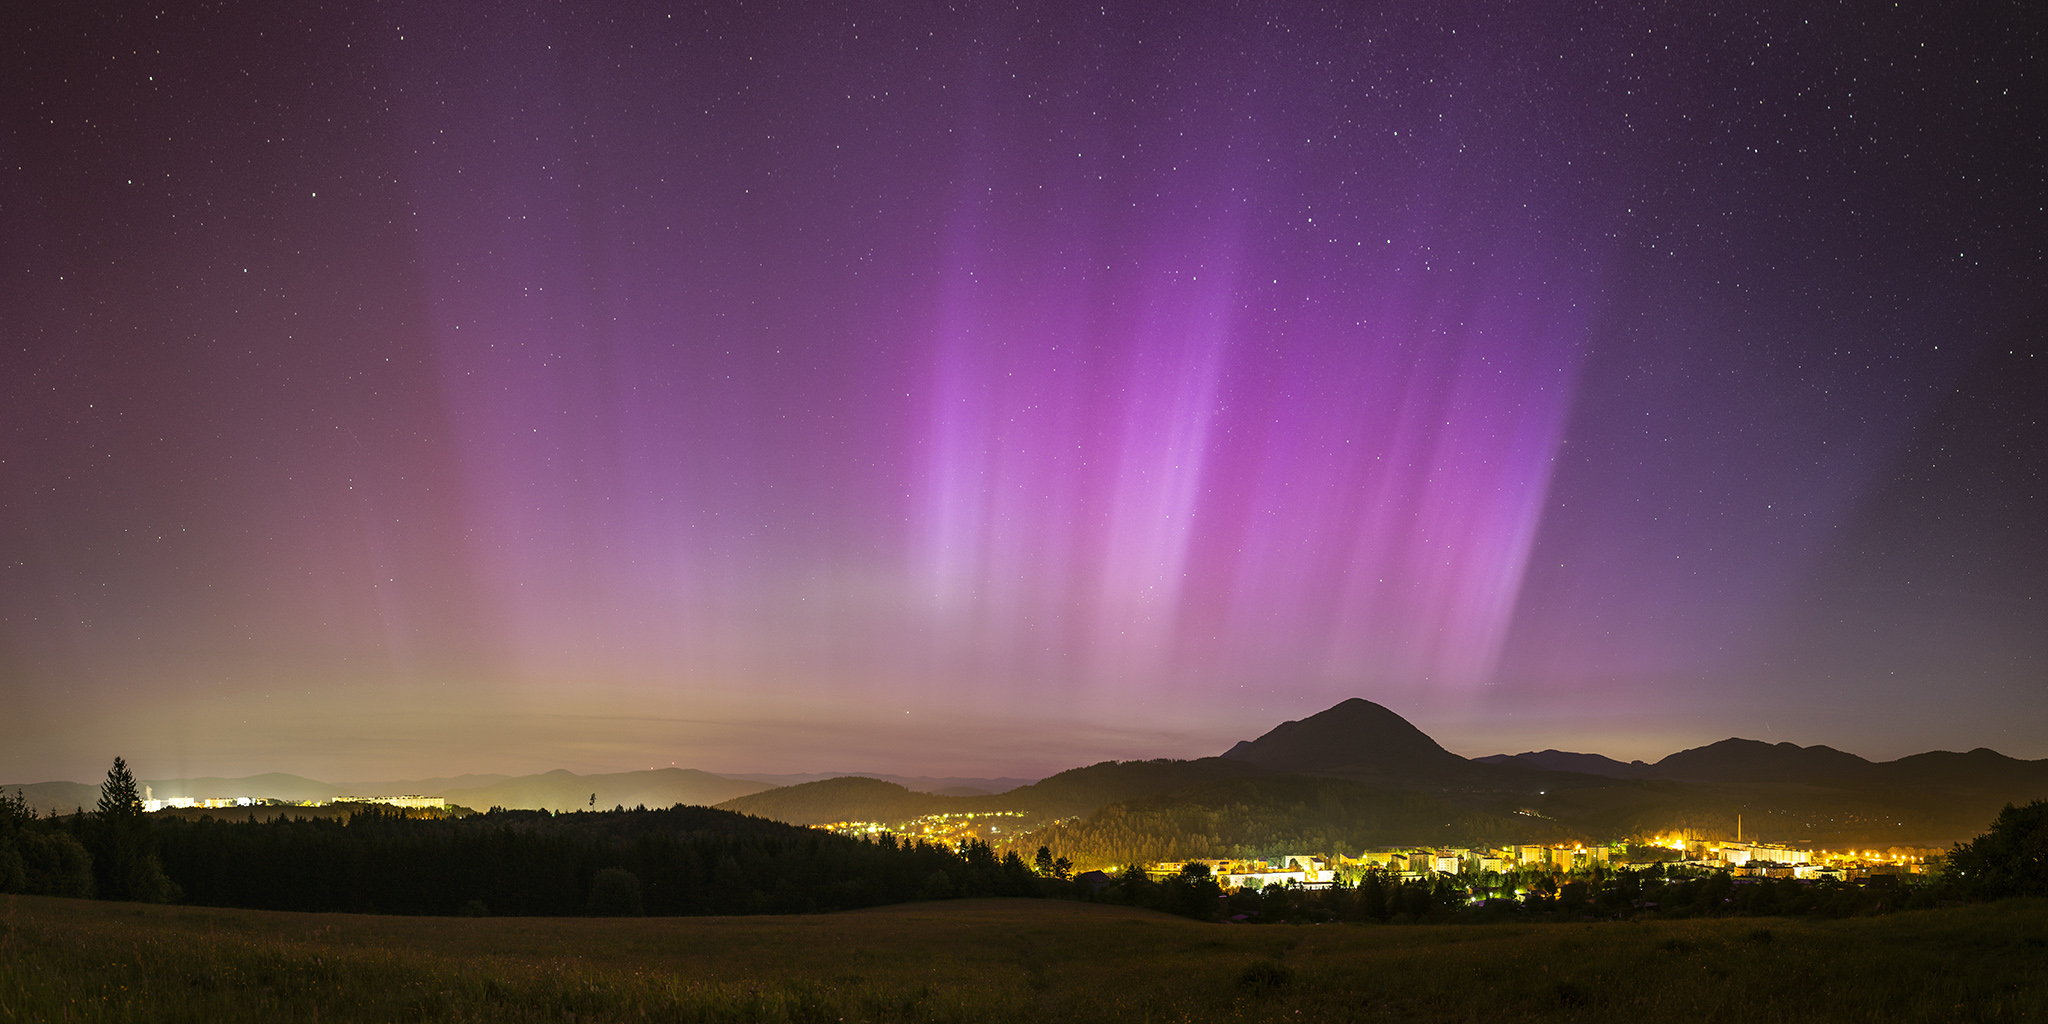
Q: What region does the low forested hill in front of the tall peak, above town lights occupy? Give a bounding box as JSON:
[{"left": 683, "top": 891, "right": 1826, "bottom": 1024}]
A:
[{"left": 1014, "top": 774, "right": 1567, "bottom": 868}]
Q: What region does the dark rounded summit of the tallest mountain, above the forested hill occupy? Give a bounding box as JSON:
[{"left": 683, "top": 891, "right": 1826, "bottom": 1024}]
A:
[{"left": 1223, "top": 696, "right": 1473, "bottom": 774}]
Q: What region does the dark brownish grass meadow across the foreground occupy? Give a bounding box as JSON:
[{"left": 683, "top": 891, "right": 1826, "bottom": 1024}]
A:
[{"left": 0, "top": 897, "right": 2048, "bottom": 1024}]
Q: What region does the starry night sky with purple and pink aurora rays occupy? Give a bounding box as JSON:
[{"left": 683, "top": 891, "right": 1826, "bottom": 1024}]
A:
[{"left": 0, "top": 0, "right": 2048, "bottom": 780}]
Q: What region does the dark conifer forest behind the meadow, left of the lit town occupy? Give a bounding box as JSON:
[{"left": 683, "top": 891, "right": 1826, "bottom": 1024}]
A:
[{"left": 154, "top": 805, "right": 1036, "bottom": 915}]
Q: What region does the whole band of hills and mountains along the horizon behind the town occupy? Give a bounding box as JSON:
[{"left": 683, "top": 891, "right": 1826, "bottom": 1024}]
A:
[{"left": 16, "top": 698, "right": 2048, "bottom": 856}]
